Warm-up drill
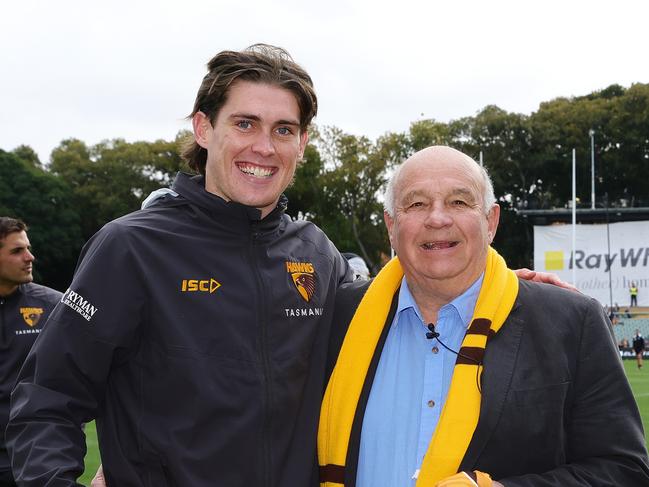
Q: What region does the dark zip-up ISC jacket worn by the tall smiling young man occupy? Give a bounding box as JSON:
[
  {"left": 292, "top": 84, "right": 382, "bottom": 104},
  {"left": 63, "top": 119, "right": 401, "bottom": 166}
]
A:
[{"left": 8, "top": 174, "right": 349, "bottom": 487}]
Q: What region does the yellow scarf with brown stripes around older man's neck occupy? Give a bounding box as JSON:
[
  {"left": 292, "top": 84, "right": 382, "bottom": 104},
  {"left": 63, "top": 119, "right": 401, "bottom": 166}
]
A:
[{"left": 318, "top": 248, "right": 518, "bottom": 487}]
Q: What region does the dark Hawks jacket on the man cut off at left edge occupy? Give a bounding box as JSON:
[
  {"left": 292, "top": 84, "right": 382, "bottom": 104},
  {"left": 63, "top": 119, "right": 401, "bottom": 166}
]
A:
[{"left": 0, "top": 282, "right": 61, "bottom": 471}]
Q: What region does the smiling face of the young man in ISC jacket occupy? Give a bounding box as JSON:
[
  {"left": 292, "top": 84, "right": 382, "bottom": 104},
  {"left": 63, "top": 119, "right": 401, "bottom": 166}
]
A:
[{"left": 193, "top": 81, "right": 308, "bottom": 217}]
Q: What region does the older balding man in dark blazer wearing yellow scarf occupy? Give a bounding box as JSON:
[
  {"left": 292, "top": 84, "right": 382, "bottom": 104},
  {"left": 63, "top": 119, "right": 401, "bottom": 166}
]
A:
[{"left": 318, "top": 147, "right": 649, "bottom": 487}]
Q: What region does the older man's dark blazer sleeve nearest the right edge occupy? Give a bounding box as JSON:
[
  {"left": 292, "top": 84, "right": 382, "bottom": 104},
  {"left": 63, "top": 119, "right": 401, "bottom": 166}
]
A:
[{"left": 488, "top": 300, "right": 649, "bottom": 487}]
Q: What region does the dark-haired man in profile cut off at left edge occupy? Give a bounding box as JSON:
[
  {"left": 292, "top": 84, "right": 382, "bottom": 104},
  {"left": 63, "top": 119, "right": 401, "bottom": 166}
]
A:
[{"left": 0, "top": 216, "right": 61, "bottom": 487}]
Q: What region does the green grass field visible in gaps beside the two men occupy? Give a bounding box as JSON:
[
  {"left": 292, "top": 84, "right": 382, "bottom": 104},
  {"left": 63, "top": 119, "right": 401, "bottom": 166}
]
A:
[{"left": 79, "top": 360, "right": 649, "bottom": 485}]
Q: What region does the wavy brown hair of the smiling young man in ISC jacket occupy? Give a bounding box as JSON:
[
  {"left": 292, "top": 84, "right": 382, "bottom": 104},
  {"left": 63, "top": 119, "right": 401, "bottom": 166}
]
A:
[{"left": 182, "top": 44, "right": 318, "bottom": 175}]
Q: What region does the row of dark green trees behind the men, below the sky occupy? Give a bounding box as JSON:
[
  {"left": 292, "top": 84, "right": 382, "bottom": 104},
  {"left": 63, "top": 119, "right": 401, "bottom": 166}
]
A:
[{"left": 0, "top": 84, "right": 649, "bottom": 288}]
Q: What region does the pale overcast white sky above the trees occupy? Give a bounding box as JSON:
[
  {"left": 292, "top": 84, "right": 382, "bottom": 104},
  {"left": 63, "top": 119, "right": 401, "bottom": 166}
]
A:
[{"left": 0, "top": 0, "right": 649, "bottom": 162}]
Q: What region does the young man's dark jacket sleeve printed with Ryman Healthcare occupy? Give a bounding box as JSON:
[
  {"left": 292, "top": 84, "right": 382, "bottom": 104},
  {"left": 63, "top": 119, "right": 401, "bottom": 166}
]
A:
[{"left": 6, "top": 226, "right": 143, "bottom": 487}]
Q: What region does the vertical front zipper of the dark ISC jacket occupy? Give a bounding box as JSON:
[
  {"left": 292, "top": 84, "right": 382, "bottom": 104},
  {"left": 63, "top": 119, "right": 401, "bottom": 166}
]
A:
[{"left": 250, "top": 226, "right": 272, "bottom": 487}]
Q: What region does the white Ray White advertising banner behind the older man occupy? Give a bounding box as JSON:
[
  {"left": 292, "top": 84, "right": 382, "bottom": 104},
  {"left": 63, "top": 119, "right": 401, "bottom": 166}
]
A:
[{"left": 534, "top": 221, "right": 649, "bottom": 309}]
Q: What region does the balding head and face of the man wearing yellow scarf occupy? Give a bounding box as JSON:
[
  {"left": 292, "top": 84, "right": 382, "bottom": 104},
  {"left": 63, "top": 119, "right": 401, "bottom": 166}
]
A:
[{"left": 385, "top": 148, "right": 500, "bottom": 293}]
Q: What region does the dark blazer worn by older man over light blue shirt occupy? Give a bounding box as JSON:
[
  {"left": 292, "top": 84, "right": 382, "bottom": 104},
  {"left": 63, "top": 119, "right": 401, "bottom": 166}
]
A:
[{"left": 328, "top": 281, "right": 649, "bottom": 487}]
